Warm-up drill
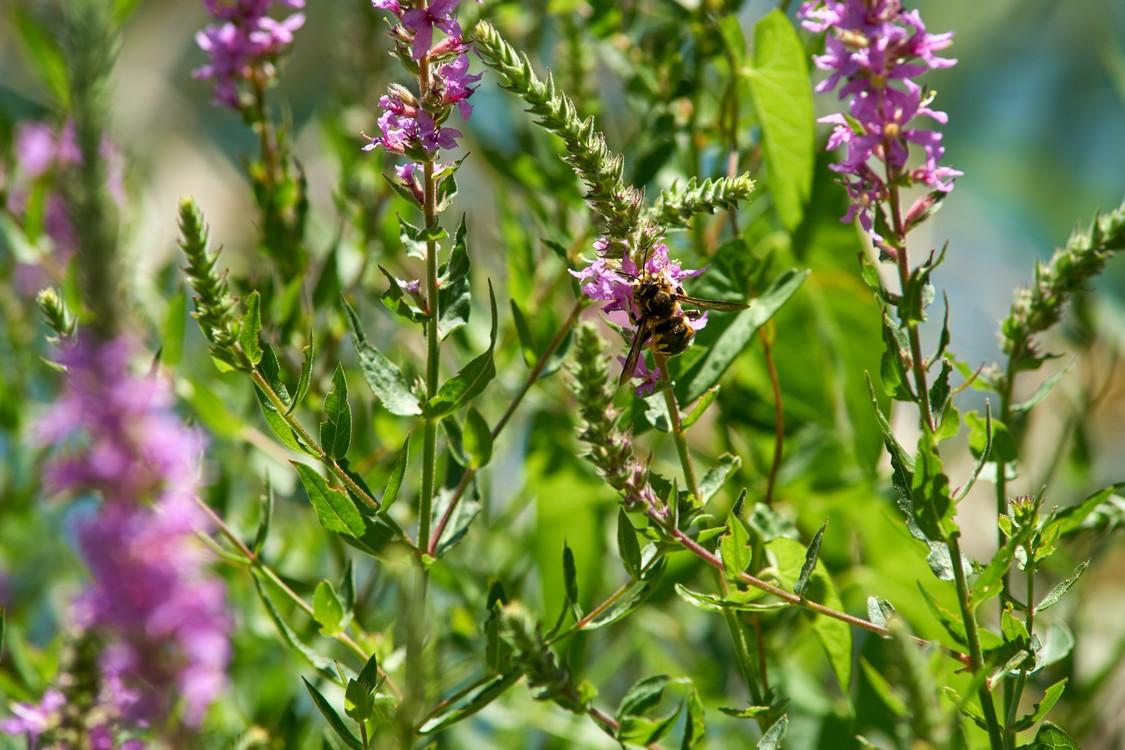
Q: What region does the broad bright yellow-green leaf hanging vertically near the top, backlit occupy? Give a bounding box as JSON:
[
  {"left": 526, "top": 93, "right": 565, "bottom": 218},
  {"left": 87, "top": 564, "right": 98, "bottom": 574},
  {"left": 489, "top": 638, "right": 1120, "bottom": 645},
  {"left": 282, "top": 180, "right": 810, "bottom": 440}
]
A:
[{"left": 749, "top": 10, "right": 816, "bottom": 232}]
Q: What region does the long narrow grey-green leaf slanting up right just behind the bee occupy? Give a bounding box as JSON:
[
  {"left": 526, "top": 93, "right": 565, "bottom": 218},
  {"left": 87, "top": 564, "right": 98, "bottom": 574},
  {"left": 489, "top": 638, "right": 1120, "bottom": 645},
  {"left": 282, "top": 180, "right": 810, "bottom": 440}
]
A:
[{"left": 676, "top": 269, "right": 809, "bottom": 404}]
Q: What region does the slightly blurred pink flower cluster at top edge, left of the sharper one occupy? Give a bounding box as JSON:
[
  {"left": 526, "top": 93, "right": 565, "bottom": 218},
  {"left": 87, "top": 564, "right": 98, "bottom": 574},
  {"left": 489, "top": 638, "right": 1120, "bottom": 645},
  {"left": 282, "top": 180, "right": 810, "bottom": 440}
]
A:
[{"left": 194, "top": 0, "right": 305, "bottom": 109}]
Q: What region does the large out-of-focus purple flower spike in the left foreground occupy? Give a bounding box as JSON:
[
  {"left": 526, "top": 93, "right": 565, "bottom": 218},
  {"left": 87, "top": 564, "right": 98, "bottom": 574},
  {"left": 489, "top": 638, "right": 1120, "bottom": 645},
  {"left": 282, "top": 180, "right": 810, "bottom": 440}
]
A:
[{"left": 6, "top": 337, "right": 230, "bottom": 747}]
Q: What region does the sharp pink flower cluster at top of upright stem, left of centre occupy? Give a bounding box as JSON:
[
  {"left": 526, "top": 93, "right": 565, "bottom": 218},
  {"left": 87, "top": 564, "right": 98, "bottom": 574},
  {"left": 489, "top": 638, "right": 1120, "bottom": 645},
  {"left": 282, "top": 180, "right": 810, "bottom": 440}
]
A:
[{"left": 363, "top": 0, "right": 480, "bottom": 196}]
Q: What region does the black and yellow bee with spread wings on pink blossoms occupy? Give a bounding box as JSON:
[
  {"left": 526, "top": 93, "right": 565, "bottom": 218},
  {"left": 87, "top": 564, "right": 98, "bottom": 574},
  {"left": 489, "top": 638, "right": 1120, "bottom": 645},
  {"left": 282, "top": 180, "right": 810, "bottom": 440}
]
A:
[{"left": 618, "top": 259, "right": 749, "bottom": 386}]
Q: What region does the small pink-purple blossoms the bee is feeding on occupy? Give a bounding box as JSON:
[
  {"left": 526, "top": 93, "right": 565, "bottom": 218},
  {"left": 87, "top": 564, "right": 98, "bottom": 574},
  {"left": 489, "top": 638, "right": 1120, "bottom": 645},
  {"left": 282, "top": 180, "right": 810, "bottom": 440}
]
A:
[{"left": 570, "top": 237, "right": 707, "bottom": 396}]
